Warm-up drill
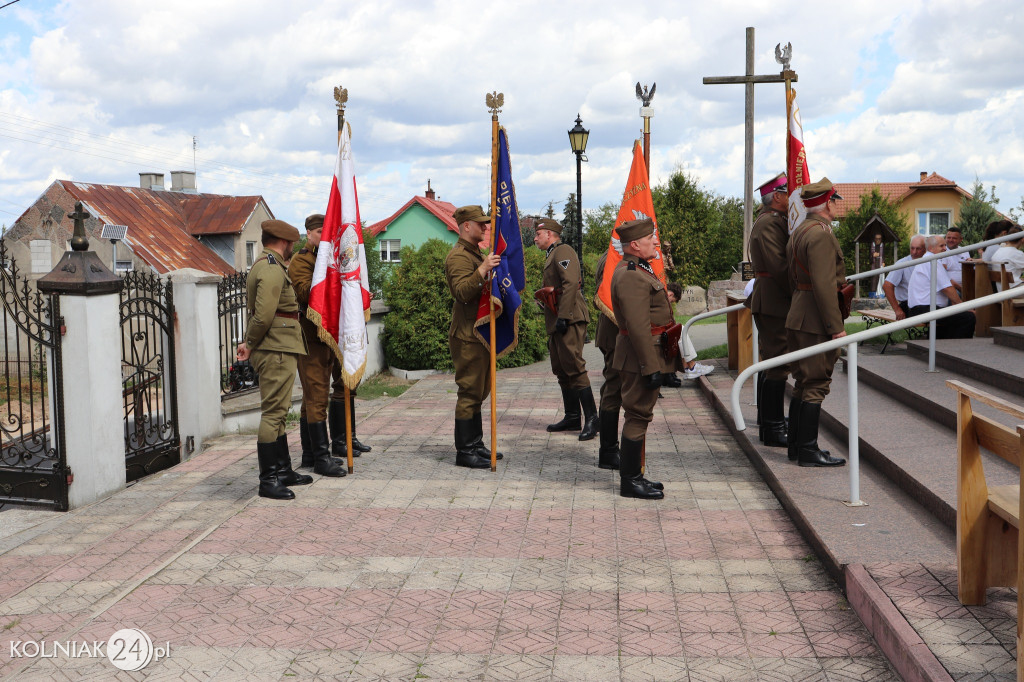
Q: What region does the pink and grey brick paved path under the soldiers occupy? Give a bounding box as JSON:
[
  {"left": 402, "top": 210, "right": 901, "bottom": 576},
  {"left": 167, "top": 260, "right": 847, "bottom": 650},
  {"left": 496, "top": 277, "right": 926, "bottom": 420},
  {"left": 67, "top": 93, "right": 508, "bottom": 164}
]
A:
[{"left": 0, "top": 363, "right": 896, "bottom": 681}]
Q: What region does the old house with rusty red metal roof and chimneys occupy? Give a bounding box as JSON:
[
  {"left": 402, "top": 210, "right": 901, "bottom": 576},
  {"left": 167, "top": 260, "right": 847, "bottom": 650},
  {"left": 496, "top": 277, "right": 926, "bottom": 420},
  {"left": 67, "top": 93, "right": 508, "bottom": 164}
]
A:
[{"left": 3, "top": 171, "right": 273, "bottom": 279}]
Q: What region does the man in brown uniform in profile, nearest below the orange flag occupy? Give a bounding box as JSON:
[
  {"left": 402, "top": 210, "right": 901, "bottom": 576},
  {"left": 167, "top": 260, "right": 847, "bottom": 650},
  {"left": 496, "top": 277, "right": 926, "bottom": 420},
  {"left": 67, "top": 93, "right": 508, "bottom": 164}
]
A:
[{"left": 611, "top": 218, "right": 683, "bottom": 500}]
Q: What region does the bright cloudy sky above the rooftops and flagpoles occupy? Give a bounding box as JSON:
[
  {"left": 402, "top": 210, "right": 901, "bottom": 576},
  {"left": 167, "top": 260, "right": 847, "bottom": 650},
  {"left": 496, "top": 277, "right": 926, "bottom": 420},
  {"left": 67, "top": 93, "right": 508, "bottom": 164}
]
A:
[{"left": 0, "top": 0, "right": 1024, "bottom": 227}]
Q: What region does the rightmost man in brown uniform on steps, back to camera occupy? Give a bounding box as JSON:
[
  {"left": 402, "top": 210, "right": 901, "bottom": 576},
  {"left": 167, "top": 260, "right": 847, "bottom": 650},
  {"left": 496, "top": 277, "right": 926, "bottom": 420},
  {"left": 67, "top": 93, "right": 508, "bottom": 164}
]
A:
[{"left": 785, "top": 178, "right": 846, "bottom": 467}]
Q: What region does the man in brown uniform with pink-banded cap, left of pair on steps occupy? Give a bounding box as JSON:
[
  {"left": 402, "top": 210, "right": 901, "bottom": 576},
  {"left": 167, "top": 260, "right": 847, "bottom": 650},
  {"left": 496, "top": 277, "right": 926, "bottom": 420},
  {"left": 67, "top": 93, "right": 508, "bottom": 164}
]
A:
[{"left": 750, "top": 173, "right": 792, "bottom": 447}]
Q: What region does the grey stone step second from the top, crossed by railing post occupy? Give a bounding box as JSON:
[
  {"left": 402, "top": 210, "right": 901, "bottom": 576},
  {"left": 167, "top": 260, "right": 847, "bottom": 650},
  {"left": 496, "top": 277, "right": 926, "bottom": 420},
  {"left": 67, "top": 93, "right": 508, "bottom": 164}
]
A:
[{"left": 906, "top": 339, "right": 1024, "bottom": 400}]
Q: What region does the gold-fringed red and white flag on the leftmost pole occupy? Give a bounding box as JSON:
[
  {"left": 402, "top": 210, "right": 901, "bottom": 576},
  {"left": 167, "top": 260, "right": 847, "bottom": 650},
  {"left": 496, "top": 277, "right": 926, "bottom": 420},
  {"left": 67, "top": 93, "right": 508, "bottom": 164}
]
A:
[{"left": 306, "top": 125, "right": 370, "bottom": 390}]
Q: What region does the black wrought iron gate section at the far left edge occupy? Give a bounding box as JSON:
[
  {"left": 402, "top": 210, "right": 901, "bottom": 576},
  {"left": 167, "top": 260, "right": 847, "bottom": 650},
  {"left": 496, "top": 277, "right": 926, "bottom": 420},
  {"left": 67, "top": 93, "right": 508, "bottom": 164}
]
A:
[{"left": 0, "top": 242, "right": 71, "bottom": 511}]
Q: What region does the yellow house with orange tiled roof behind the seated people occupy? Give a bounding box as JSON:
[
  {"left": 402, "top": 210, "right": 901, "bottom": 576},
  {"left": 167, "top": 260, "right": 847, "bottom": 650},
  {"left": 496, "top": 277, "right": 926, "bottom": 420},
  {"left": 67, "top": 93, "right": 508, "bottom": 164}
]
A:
[{"left": 836, "top": 171, "right": 971, "bottom": 235}]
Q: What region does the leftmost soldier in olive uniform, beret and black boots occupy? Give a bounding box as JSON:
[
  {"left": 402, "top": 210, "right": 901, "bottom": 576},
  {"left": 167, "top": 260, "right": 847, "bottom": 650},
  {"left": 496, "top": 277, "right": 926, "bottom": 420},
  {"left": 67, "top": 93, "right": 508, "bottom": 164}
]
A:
[{"left": 237, "top": 220, "right": 313, "bottom": 500}]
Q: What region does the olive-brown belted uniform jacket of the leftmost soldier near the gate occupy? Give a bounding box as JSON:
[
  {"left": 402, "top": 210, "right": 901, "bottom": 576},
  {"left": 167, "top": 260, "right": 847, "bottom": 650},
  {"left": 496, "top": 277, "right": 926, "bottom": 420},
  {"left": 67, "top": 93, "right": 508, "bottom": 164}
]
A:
[{"left": 246, "top": 249, "right": 306, "bottom": 355}]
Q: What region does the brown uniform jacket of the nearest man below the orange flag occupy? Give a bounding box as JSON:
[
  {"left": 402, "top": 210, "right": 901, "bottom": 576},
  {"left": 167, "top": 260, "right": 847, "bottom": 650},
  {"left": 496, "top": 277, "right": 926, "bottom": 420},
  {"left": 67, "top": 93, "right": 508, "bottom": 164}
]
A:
[{"left": 611, "top": 254, "right": 682, "bottom": 376}]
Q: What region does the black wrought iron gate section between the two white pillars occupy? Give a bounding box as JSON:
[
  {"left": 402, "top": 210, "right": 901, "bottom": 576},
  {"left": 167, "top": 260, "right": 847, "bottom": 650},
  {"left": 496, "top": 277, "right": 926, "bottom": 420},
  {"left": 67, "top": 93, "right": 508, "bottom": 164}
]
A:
[{"left": 121, "top": 271, "right": 181, "bottom": 480}]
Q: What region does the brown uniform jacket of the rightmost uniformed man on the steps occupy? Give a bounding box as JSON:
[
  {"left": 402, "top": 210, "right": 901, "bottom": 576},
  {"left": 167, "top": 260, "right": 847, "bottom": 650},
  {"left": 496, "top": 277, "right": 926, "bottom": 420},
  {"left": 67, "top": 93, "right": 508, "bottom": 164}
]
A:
[{"left": 785, "top": 214, "right": 846, "bottom": 336}]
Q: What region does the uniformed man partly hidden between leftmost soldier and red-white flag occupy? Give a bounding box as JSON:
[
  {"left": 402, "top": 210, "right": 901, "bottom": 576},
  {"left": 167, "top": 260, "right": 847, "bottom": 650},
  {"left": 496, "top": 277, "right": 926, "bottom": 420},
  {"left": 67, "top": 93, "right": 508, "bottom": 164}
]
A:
[{"left": 288, "top": 213, "right": 345, "bottom": 477}]
